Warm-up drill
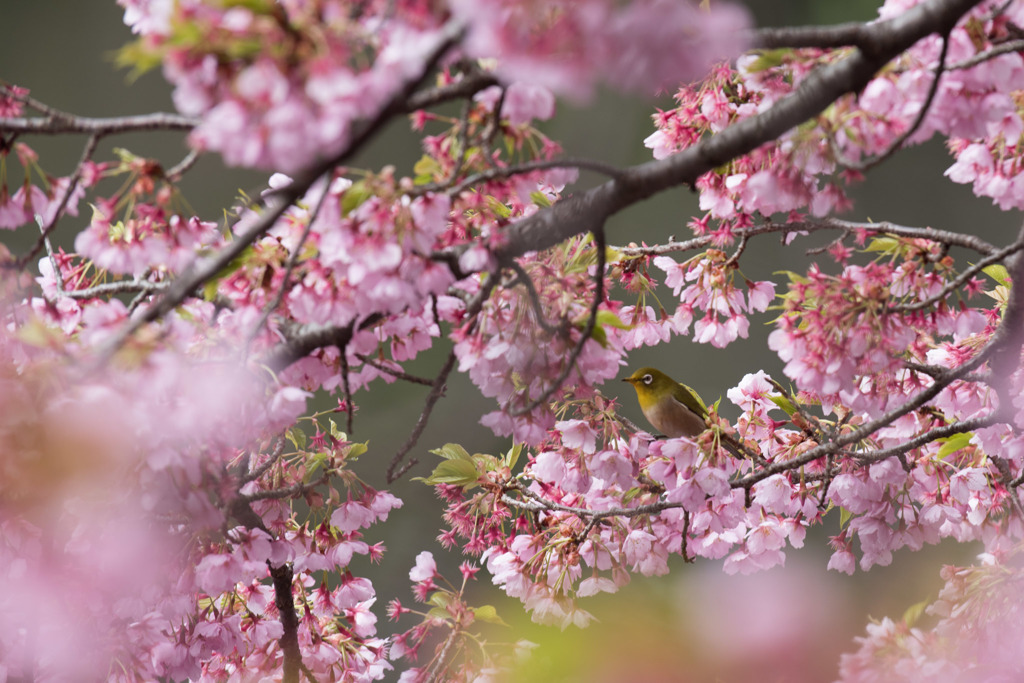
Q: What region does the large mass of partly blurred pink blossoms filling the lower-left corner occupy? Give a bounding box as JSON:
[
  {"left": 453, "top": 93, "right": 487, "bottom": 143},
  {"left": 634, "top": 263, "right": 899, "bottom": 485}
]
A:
[{"left": 0, "top": 258, "right": 413, "bottom": 680}]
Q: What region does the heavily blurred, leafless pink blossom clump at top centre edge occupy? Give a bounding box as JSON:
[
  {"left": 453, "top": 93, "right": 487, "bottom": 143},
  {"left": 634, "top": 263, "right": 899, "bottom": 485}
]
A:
[{"left": 451, "top": 0, "right": 750, "bottom": 99}]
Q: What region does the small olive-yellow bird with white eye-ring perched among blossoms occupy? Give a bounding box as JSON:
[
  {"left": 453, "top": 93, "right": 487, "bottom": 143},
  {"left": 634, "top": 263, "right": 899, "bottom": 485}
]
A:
[{"left": 623, "top": 368, "right": 743, "bottom": 458}]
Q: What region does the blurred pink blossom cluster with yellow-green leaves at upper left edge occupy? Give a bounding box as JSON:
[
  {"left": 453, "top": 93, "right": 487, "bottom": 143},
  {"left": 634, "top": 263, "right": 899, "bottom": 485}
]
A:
[{"left": 121, "top": 0, "right": 443, "bottom": 172}]
